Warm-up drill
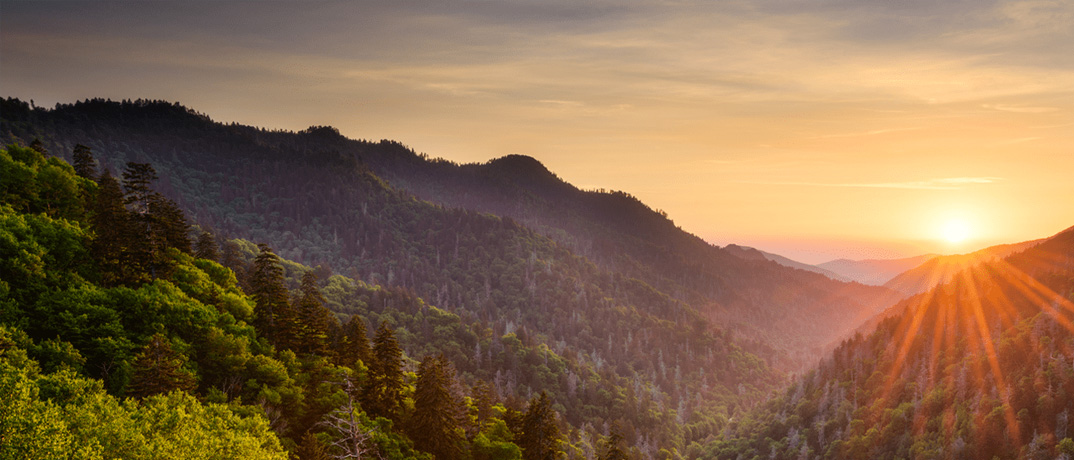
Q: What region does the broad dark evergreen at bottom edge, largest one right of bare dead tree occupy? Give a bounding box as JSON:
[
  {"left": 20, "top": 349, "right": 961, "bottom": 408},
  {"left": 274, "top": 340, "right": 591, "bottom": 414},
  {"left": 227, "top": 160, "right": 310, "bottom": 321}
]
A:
[{"left": 407, "top": 355, "right": 466, "bottom": 459}]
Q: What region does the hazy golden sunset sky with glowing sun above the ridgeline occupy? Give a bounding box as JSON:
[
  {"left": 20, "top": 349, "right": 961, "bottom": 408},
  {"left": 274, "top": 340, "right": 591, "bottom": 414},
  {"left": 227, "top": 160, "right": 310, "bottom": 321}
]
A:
[{"left": 0, "top": 0, "right": 1074, "bottom": 263}]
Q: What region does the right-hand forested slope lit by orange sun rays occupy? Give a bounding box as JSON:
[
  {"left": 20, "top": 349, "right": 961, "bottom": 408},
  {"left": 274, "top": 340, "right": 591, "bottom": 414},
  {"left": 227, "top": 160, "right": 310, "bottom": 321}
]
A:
[{"left": 706, "top": 225, "right": 1074, "bottom": 459}]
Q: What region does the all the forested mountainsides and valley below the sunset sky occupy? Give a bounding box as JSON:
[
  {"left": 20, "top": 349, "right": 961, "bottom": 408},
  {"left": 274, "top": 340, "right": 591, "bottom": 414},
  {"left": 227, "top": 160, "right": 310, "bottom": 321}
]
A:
[{"left": 6, "top": 99, "right": 1074, "bottom": 460}]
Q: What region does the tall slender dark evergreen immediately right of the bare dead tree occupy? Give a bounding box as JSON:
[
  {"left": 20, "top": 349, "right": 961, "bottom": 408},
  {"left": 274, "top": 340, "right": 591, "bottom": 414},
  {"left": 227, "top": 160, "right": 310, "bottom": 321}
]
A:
[{"left": 361, "top": 322, "right": 405, "bottom": 421}]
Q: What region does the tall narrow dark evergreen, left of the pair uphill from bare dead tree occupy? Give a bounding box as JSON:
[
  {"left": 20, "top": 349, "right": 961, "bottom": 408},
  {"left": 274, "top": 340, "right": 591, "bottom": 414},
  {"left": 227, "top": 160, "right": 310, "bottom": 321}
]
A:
[{"left": 249, "top": 243, "right": 290, "bottom": 343}]
